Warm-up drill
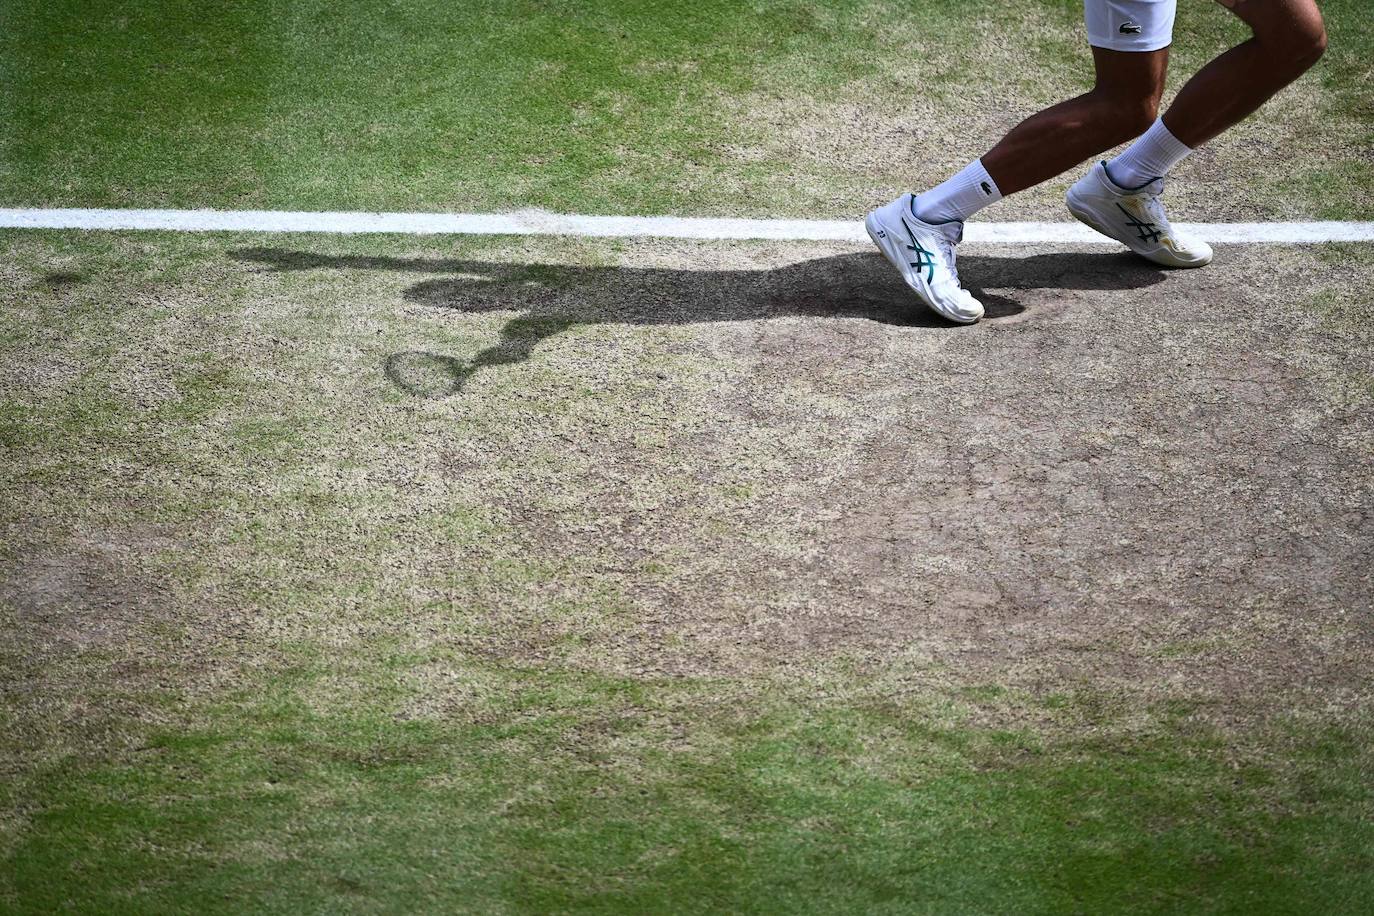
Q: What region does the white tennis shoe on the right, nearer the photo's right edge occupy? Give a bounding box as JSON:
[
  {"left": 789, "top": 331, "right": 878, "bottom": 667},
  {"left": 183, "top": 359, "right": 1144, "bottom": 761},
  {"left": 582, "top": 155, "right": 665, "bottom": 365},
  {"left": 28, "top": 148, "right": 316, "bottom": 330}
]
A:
[{"left": 1065, "top": 162, "right": 1212, "bottom": 268}]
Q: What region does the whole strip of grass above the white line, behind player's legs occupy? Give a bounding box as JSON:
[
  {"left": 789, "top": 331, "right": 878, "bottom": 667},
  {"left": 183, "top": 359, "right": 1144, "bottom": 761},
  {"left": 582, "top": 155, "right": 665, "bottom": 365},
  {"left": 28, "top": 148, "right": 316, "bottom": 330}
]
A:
[{"left": 0, "top": 0, "right": 1374, "bottom": 218}]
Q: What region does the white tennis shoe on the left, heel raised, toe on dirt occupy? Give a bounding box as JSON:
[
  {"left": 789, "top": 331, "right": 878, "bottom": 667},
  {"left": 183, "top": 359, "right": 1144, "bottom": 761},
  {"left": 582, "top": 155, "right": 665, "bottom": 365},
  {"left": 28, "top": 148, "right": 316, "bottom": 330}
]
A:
[{"left": 863, "top": 194, "right": 982, "bottom": 324}]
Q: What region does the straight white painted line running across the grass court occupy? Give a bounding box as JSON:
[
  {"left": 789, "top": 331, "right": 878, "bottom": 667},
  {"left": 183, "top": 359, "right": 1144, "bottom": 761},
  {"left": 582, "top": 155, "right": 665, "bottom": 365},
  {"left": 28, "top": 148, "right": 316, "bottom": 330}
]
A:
[{"left": 0, "top": 207, "right": 1374, "bottom": 244}]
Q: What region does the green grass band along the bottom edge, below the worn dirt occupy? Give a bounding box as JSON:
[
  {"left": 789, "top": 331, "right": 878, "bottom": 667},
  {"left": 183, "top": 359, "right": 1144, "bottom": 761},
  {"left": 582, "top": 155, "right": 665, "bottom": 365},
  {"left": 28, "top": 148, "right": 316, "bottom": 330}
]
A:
[{"left": 7, "top": 652, "right": 1374, "bottom": 912}]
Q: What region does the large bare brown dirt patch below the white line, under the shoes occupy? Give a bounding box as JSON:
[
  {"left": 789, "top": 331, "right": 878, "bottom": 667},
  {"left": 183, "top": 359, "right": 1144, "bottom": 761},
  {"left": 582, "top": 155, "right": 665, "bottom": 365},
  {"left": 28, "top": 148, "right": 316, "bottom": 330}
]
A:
[{"left": 321, "top": 243, "right": 1374, "bottom": 714}]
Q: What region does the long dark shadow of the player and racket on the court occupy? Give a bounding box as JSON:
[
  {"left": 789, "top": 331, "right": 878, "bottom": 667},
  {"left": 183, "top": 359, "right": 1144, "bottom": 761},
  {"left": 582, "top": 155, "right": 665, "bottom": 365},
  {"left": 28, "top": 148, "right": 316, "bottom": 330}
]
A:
[{"left": 232, "top": 247, "right": 1164, "bottom": 397}]
